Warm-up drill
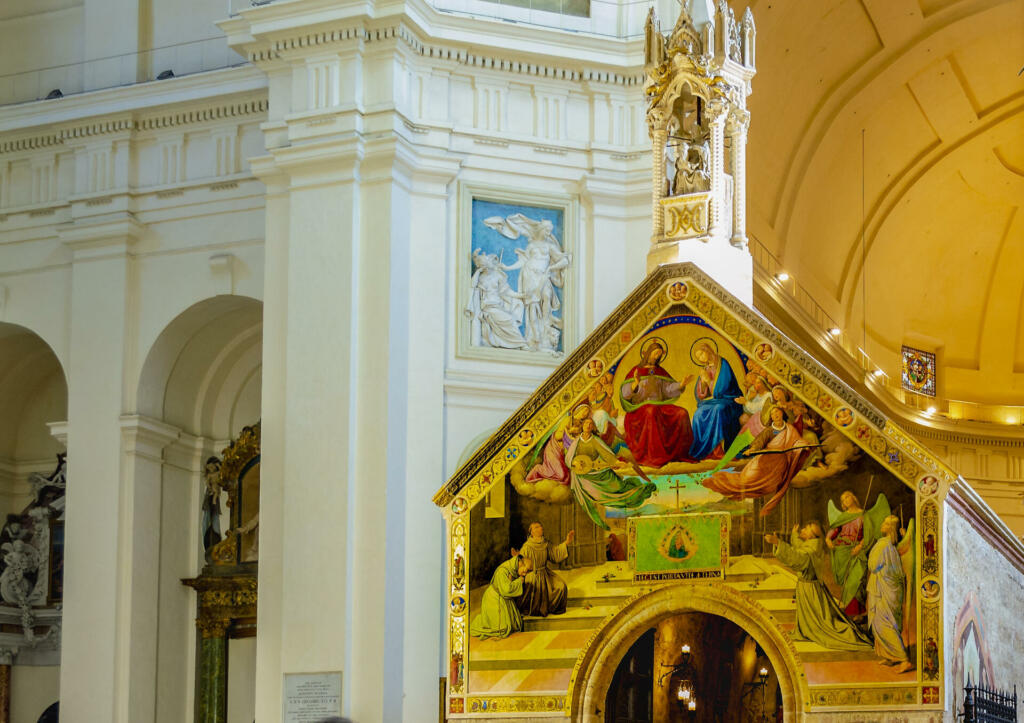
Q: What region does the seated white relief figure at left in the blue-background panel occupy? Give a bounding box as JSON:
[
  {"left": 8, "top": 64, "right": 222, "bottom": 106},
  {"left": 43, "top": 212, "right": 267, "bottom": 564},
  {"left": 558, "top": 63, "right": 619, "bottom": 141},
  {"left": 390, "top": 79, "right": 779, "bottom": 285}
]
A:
[{"left": 465, "top": 249, "right": 527, "bottom": 349}]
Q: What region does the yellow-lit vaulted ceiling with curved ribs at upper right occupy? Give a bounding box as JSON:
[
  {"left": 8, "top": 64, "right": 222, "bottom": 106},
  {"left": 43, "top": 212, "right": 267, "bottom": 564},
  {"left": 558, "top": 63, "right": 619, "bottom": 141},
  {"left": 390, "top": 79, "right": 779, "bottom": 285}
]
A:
[{"left": 734, "top": 0, "right": 1024, "bottom": 405}]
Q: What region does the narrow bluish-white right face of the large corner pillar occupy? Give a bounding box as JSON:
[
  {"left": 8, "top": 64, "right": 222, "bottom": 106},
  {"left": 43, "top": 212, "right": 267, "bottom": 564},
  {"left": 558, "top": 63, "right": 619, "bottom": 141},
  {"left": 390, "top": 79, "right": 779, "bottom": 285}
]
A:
[{"left": 380, "top": 147, "right": 459, "bottom": 723}]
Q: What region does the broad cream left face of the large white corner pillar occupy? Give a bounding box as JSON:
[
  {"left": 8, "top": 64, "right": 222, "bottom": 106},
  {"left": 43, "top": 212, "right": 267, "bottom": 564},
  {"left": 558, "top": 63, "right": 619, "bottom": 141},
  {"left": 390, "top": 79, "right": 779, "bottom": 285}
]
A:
[{"left": 246, "top": 140, "right": 360, "bottom": 721}]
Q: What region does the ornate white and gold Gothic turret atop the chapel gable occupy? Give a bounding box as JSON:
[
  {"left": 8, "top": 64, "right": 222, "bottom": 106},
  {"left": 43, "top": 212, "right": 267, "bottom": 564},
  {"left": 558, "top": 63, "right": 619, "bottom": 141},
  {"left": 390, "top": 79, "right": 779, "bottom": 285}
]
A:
[{"left": 644, "top": 0, "right": 756, "bottom": 302}]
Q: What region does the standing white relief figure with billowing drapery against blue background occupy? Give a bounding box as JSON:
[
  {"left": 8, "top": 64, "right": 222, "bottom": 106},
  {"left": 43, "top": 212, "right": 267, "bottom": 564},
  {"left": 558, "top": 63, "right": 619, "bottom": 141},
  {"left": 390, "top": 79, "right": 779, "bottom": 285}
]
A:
[{"left": 483, "top": 213, "right": 572, "bottom": 351}]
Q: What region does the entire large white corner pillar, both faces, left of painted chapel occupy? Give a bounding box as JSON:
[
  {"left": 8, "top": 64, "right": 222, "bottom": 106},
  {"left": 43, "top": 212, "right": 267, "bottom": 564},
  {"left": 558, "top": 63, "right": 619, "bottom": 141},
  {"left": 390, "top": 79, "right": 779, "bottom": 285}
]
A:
[{"left": 254, "top": 131, "right": 458, "bottom": 721}]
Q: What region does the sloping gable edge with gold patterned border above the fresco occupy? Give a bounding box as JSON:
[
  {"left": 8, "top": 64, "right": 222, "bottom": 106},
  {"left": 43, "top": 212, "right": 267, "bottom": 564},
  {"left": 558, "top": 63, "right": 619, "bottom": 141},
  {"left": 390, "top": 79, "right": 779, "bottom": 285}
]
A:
[{"left": 433, "top": 263, "right": 958, "bottom": 512}]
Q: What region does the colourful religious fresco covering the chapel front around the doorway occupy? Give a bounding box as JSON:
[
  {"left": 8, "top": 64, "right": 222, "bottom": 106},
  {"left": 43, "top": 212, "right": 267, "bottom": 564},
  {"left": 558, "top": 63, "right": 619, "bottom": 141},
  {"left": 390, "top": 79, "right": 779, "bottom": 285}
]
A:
[{"left": 436, "top": 268, "right": 939, "bottom": 714}]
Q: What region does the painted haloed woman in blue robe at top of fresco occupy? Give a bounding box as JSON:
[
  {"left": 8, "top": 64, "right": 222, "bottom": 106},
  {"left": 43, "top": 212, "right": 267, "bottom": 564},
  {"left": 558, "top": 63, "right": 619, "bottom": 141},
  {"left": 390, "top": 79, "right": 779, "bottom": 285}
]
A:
[{"left": 689, "top": 339, "right": 743, "bottom": 460}]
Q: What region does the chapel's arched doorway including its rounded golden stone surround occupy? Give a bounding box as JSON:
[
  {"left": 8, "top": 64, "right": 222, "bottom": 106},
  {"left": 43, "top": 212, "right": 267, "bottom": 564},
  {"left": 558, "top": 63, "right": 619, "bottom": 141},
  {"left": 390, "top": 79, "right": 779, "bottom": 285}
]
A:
[{"left": 568, "top": 582, "right": 806, "bottom": 723}]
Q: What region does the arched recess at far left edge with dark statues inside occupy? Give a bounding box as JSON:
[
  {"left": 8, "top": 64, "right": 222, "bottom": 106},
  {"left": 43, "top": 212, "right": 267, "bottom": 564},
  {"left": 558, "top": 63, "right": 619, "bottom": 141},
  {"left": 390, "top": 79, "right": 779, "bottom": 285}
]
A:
[{"left": 0, "top": 324, "right": 68, "bottom": 721}]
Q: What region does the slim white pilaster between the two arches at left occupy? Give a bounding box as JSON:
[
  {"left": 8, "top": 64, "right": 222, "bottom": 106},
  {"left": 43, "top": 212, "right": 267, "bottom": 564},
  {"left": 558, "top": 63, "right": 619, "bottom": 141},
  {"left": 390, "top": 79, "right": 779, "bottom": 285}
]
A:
[{"left": 60, "top": 214, "right": 141, "bottom": 723}]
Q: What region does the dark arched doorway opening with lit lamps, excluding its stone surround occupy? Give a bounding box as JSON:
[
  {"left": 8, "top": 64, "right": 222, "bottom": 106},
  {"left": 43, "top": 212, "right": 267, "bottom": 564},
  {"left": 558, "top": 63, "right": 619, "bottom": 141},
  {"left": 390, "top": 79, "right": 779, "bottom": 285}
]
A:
[{"left": 604, "top": 612, "right": 782, "bottom": 723}]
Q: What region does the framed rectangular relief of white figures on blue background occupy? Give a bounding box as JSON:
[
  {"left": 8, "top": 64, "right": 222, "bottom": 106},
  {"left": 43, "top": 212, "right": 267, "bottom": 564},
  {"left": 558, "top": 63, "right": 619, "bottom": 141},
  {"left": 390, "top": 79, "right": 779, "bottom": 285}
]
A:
[{"left": 455, "top": 183, "right": 580, "bottom": 367}]
